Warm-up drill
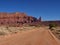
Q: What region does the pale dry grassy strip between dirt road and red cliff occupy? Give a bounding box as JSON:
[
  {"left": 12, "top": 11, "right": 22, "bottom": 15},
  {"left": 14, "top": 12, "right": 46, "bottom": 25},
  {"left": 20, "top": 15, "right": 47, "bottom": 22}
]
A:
[{"left": 0, "top": 26, "right": 36, "bottom": 35}]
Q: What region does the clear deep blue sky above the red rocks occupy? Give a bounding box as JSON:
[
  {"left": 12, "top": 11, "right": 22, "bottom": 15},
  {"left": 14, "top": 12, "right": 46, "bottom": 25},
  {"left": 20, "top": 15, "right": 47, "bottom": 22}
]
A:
[{"left": 0, "top": 0, "right": 60, "bottom": 20}]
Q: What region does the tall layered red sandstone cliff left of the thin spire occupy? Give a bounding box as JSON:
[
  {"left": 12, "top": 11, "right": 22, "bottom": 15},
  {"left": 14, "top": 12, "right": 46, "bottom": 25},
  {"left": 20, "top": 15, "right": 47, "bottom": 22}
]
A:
[{"left": 0, "top": 12, "right": 38, "bottom": 26}]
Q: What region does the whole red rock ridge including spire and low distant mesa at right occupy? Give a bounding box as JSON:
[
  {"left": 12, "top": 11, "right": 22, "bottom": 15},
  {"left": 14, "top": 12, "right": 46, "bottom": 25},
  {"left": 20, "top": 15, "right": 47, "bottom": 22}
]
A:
[{"left": 0, "top": 12, "right": 60, "bottom": 26}]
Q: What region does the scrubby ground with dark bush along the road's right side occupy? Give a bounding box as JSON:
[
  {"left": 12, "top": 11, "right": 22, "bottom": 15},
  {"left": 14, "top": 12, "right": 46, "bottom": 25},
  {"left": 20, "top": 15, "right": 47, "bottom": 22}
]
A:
[{"left": 49, "top": 24, "right": 60, "bottom": 39}]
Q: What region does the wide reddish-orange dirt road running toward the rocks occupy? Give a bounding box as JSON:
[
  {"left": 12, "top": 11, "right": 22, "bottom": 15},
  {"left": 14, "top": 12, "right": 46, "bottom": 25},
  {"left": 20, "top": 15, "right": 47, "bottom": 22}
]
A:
[{"left": 0, "top": 28, "right": 60, "bottom": 45}]
